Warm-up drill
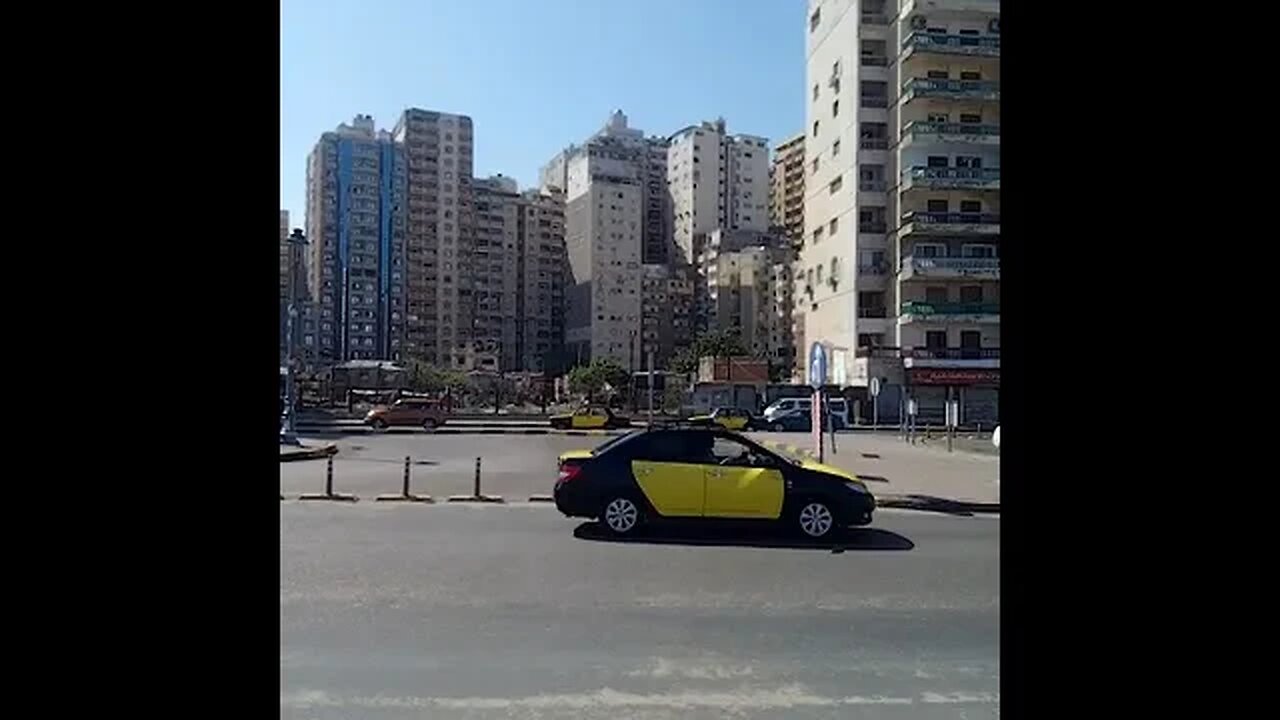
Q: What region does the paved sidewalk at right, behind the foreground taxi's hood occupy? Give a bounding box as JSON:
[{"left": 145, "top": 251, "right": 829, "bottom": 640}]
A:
[{"left": 757, "top": 433, "right": 1000, "bottom": 505}]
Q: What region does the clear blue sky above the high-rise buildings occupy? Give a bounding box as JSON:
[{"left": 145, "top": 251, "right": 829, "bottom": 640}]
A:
[{"left": 280, "top": 0, "right": 806, "bottom": 227}]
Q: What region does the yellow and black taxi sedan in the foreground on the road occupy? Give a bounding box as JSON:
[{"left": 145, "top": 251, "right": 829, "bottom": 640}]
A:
[{"left": 554, "top": 427, "right": 876, "bottom": 538}]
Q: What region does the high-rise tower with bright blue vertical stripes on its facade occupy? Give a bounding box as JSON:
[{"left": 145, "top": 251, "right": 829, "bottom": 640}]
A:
[{"left": 306, "top": 115, "right": 406, "bottom": 363}]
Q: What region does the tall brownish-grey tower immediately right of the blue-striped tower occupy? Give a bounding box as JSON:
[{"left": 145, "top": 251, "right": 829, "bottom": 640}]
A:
[{"left": 392, "top": 108, "right": 478, "bottom": 368}]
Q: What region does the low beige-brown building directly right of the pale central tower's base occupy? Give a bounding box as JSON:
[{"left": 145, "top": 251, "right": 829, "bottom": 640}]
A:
[{"left": 641, "top": 264, "right": 696, "bottom": 369}]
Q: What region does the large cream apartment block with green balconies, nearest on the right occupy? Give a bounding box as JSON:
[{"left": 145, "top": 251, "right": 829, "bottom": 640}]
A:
[{"left": 797, "top": 0, "right": 1000, "bottom": 423}]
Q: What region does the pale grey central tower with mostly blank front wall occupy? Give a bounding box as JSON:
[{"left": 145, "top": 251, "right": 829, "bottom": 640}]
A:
[{"left": 541, "top": 110, "right": 653, "bottom": 368}]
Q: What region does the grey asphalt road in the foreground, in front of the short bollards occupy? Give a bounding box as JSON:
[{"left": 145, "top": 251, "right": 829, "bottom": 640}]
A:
[{"left": 280, "top": 502, "right": 1000, "bottom": 720}]
